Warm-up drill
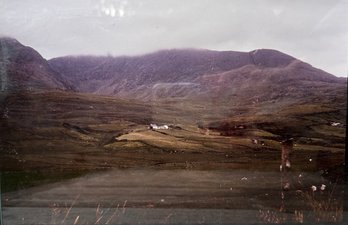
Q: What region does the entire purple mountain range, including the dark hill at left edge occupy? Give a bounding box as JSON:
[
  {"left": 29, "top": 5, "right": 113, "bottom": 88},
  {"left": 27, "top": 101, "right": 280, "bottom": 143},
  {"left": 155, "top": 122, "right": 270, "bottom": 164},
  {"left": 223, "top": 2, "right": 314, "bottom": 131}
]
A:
[{"left": 0, "top": 38, "right": 347, "bottom": 107}]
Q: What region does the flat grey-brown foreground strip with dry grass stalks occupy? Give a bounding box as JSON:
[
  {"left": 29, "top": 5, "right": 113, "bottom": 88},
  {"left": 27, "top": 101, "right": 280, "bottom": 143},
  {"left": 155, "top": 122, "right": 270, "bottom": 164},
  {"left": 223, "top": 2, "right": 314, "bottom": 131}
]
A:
[{"left": 3, "top": 170, "right": 343, "bottom": 225}]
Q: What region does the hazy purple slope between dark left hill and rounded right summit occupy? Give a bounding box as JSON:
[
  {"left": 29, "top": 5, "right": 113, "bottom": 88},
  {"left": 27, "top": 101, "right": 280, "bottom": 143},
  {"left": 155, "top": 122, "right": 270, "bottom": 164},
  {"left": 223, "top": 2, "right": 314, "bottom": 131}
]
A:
[{"left": 50, "top": 50, "right": 260, "bottom": 99}]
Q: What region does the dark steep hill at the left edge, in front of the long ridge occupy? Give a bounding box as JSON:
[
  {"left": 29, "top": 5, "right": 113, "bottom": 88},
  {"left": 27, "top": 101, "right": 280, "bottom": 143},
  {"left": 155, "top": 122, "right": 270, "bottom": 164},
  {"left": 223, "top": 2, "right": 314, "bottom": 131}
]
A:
[{"left": 0, "top": 37, "right": 71, "bottom": 91}]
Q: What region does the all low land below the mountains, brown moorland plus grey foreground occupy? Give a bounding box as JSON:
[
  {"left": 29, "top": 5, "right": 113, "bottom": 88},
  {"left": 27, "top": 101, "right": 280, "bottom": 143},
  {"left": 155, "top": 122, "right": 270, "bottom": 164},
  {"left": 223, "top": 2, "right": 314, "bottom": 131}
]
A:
[{"left": 0, "top": 91, "right": 345, "bottom": 224}]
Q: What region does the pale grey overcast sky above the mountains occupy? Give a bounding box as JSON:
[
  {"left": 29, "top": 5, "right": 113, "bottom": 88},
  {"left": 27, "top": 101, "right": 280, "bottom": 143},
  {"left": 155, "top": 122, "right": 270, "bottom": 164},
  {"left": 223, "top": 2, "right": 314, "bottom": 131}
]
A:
[{"left": 0, "top": 0, "right": 348, "bottom": 76}]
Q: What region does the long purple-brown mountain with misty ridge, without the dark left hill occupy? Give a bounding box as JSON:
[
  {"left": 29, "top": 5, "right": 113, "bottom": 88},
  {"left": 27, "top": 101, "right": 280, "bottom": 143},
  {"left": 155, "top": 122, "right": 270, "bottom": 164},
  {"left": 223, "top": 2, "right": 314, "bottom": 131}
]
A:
[{"left": 49, "top": 49, "right": 346, "bottom": 102}]
